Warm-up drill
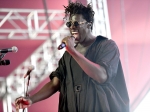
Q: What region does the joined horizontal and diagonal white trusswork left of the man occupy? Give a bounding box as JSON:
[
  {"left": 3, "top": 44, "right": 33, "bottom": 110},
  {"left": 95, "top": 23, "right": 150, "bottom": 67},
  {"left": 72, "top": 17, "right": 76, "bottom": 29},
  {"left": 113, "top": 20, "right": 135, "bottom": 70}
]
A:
[{"left": 0, "top": 9, "right": 69, "bottom": 112}]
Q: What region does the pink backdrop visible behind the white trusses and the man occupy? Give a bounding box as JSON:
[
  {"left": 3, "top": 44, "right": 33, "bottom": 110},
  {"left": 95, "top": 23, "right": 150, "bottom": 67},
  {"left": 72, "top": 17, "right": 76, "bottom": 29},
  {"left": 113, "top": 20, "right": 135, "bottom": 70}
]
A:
[{"left": 0, "top": 0, "right": 150, "bottom": 112}]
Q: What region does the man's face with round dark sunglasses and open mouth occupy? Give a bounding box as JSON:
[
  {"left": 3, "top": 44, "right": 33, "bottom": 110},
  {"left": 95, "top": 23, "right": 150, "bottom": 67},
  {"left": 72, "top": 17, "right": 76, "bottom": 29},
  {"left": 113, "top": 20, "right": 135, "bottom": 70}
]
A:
[{"left": 68, "top": 14, "right": 89, "bottom": 43}]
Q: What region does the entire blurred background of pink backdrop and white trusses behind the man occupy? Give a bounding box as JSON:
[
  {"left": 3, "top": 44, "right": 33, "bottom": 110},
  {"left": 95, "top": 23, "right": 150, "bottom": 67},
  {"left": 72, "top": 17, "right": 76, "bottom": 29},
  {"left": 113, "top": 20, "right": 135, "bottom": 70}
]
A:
[{"left": 0, "top": 0, "right": 150, "bottom": 112}]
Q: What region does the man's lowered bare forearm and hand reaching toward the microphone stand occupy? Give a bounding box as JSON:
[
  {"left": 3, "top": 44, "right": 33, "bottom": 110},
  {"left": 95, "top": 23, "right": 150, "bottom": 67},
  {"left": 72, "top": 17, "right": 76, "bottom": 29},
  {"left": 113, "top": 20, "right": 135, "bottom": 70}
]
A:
[{"left": 15, "top": 77, "right": 60, "bottom": 112}]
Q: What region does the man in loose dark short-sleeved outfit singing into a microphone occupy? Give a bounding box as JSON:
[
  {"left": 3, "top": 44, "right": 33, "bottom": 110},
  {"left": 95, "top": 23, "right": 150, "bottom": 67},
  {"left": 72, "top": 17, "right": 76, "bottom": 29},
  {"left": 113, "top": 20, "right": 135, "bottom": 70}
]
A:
[{"left": 16, "top": 2, "right": 129, "bottom": 112}]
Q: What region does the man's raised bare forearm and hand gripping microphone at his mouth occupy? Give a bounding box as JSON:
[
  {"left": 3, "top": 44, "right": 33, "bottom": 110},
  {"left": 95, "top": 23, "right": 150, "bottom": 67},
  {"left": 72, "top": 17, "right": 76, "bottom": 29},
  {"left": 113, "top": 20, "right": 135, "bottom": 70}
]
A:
[{"left": 64, "top": 37, "right": 107, "bottom": 83}]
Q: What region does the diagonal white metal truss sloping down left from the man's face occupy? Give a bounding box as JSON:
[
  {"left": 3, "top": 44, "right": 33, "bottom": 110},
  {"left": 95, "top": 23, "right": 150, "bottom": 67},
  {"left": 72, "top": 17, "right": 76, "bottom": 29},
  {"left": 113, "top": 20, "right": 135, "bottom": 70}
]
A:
[{"left": 1, "top": 24, "right": 69, "bottom": 112}]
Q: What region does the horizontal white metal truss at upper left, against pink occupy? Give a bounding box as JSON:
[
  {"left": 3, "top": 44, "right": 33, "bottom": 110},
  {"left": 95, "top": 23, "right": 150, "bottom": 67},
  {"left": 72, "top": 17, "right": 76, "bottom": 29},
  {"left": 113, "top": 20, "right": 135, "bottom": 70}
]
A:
[{"left": 0, "top": 9, "right": 66, "bottom": 39}]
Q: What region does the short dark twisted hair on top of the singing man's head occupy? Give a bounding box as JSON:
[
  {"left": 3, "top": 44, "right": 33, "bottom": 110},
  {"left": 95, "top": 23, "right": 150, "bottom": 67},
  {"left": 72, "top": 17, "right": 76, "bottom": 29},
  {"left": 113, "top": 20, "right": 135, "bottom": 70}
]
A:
[{"left": 64, "top": 2, "right": 95, "bottom": 29}]
